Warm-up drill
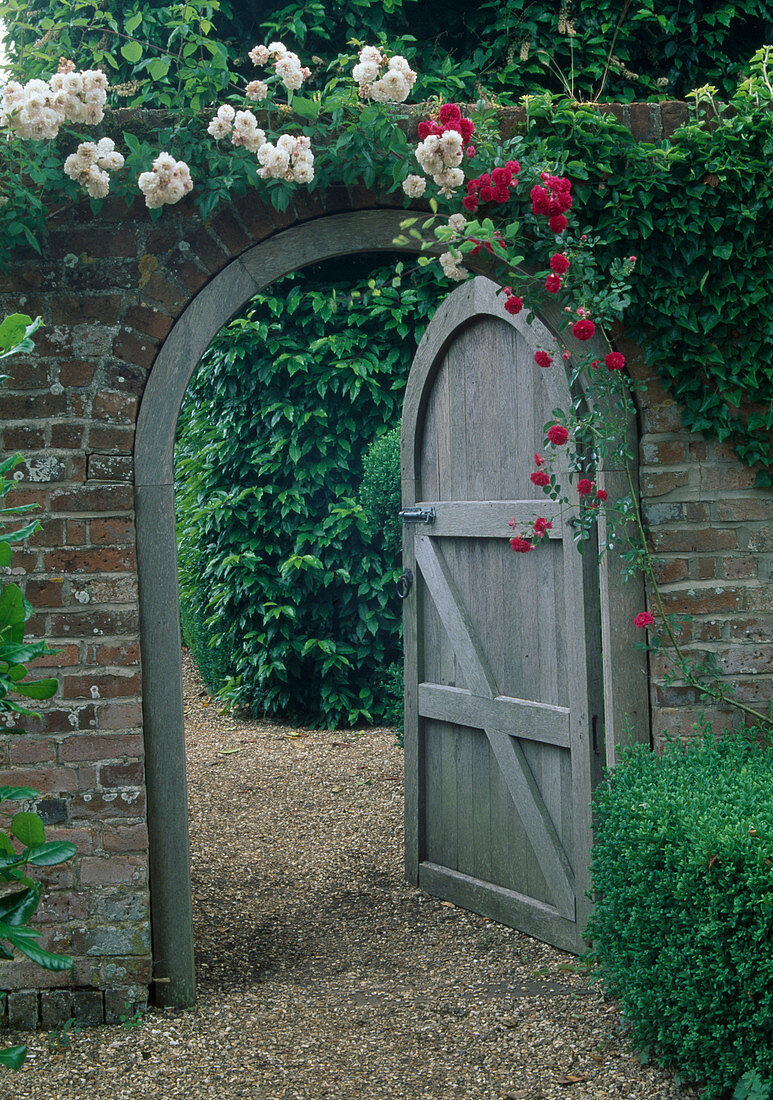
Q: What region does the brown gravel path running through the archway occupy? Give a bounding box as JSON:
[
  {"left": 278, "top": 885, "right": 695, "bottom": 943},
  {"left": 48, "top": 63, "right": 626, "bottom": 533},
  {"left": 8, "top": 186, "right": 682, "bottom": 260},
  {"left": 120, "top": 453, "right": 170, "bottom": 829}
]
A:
[{"left": 0, "top": 651, "right": 697, "bottom": 1100}]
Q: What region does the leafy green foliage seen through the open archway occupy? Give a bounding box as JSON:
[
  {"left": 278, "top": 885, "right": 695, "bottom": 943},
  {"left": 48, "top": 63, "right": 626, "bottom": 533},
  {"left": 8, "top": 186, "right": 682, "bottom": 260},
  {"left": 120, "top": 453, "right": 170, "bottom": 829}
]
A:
[{"left": 176, "top": 253, "right": 441, "bottom": 728}]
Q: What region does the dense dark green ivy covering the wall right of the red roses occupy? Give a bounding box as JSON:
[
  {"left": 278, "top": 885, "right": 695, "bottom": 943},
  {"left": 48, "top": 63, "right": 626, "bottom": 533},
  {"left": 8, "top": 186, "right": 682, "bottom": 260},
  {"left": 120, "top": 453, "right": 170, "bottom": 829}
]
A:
[{"left": 514, "top": 94, "right": 773, "bottom": 475}]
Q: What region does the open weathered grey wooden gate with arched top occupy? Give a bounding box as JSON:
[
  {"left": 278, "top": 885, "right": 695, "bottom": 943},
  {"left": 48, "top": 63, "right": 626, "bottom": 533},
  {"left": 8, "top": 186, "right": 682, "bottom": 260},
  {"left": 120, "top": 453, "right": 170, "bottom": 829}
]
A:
[{"left": 402, "top": 278, "right": 604, "bottom": 952}]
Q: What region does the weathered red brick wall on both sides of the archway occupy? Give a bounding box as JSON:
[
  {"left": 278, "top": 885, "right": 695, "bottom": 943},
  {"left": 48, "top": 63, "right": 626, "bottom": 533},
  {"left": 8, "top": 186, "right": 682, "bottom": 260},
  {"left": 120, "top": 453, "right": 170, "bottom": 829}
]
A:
[{"left": 0, "top": 105, "right": 773, "bottom": 1025}]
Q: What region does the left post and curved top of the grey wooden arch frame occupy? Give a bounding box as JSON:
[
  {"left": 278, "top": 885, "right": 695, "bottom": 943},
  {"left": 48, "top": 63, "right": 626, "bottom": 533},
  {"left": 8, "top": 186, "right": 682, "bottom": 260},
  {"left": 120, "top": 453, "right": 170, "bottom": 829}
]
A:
[{"left": 134, "top": 209, "right": 646, "bottom": 1005}]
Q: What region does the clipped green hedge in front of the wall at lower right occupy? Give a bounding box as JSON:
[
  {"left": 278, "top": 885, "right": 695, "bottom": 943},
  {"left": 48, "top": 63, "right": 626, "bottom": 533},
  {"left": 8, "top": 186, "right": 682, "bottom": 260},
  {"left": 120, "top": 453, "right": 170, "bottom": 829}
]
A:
[{"left": 588, "top": 737, "right": 773, "bottom": 1098}]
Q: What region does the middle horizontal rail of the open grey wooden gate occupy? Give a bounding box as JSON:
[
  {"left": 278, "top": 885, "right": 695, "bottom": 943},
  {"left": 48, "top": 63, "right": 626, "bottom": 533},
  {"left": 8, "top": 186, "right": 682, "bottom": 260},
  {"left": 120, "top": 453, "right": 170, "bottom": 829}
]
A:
[{"left": 419, "top": 683, "right": 570, "bottom": 748}]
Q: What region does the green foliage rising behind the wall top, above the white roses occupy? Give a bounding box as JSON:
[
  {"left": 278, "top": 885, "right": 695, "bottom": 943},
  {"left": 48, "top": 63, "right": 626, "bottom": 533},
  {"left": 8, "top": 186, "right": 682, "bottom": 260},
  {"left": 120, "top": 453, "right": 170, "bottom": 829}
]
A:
[{"left": 0, "top": 0, "right": 773, "bottom": 107}]
